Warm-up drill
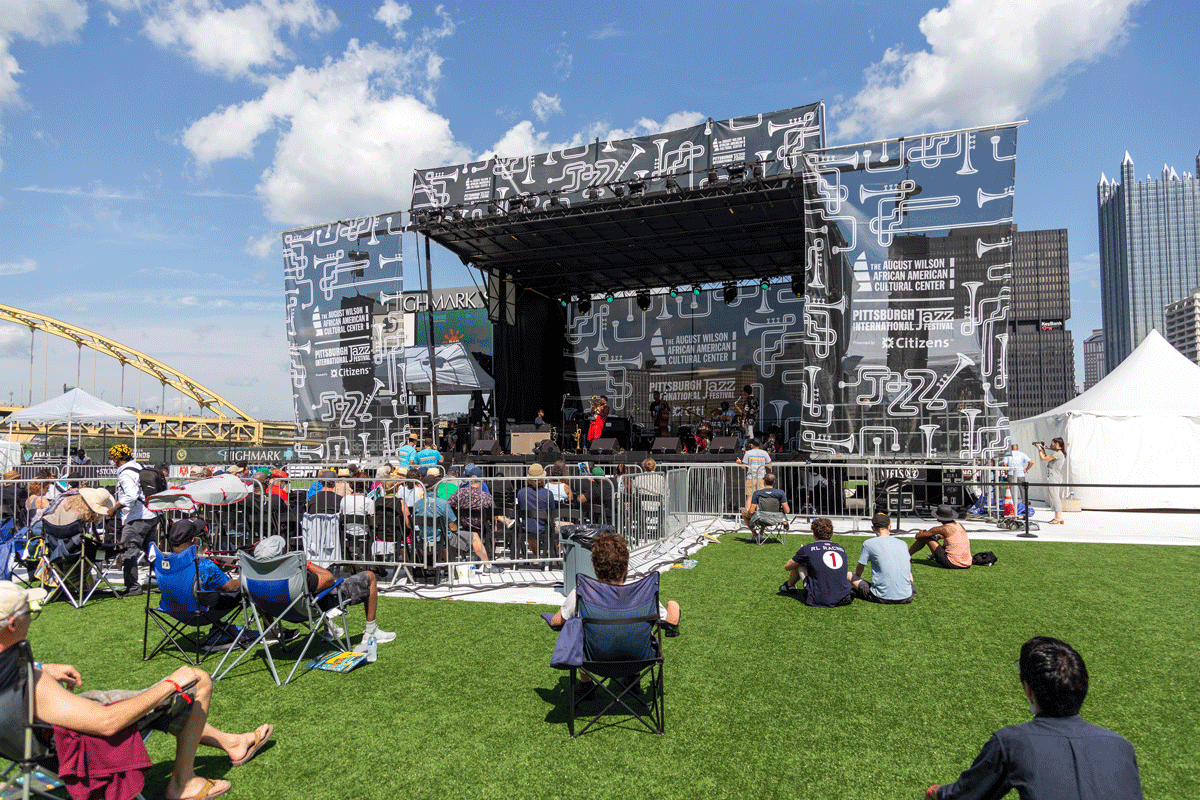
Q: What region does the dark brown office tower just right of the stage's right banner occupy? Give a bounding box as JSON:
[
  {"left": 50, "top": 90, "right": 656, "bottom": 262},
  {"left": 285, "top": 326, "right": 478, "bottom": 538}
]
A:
[{"left": 1008, "top": 225, "right": 1075, "bottom": 420}]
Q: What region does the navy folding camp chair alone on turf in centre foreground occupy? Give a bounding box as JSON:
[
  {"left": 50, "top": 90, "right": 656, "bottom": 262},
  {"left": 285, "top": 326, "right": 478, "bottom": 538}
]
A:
[{"left": 568, "top": 572, "right": 665, "bottom": 738}]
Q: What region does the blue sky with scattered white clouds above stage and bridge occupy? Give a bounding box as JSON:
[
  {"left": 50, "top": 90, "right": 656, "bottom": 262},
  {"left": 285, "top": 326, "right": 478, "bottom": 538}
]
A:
[{"left": 0, "top": 0, "right": 1200, "bottom": 419}]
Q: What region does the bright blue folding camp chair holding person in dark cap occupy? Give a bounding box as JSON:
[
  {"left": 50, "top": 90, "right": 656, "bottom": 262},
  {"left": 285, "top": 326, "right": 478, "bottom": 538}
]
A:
[{"left": 142, "top": 542, "right": 241, "bottom": 667}]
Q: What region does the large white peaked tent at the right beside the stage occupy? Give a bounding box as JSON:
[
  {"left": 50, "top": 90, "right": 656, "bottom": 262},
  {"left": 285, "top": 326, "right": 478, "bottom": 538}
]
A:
[{"left": 1012, "top": 331, "right": 1200, "bottom": 510}]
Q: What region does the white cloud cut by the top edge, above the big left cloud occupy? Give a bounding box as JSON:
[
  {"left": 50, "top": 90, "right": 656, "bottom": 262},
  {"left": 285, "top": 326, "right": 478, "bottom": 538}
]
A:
[{"left": 144, "top": 0, "right": 338, "bottom": 78}]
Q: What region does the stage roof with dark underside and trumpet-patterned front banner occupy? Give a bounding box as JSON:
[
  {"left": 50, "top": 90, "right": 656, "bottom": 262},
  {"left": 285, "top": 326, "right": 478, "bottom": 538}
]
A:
[{"left": 410, "top": 103, "right": 823, "bottom": 297}]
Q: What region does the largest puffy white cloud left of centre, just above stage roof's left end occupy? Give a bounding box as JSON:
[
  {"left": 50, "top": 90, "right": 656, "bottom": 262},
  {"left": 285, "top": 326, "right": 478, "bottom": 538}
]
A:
[{"left": 182, "top": 40, "right": 472, "bottom": 225}]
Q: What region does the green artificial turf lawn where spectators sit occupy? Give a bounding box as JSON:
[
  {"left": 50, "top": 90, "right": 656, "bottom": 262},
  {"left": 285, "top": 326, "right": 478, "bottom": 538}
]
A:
[{"left": 23, "top": 535, "right": 1200, "bottom": 800}]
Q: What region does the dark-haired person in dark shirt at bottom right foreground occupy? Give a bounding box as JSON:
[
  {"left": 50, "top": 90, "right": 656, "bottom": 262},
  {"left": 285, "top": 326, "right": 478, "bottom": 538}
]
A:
[{"left": 925, "top": 636, "right": 1142, "bottom": 800}]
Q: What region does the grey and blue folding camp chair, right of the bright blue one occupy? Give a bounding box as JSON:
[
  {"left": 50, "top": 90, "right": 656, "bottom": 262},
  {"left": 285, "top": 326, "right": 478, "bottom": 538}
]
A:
[{"left": 212, "top": 552, "right": 352, "bottom": 686}]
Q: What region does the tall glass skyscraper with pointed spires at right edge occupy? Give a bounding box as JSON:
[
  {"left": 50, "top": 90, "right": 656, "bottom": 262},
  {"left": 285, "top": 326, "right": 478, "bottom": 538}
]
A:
[{"left": 1097, "top": 152, "right": 1200, "bottom": 372}]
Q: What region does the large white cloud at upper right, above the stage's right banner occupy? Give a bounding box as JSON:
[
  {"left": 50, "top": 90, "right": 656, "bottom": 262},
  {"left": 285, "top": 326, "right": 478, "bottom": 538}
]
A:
[{"left": 833, "top": 0, "right": 1140, "bottom": 139}]
